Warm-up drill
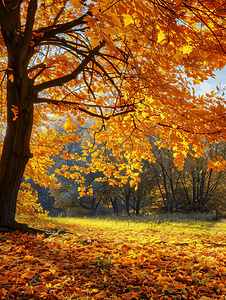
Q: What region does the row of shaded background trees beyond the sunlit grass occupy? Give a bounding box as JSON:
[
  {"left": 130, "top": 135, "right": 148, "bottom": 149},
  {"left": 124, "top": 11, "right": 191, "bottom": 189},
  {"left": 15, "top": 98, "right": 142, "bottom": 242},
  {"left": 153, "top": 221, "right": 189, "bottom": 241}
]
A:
[{"left": 47, "top": 127, "right": 226, "bottom": 216}]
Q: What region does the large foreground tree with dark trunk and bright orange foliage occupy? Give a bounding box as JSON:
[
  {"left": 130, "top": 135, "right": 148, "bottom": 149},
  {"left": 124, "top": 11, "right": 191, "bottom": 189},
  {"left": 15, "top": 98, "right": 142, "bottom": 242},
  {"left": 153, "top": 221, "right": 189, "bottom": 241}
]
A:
[{"left": 0, "top": 0, "right": 225, "bottom": 230}]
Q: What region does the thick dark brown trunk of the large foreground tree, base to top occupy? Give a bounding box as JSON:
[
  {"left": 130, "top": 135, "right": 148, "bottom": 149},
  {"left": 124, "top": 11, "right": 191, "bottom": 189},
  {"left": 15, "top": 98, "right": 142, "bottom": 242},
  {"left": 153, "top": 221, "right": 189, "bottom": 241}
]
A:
[{"left": 0, "top": 0, "right": 37, "bottom": 229}]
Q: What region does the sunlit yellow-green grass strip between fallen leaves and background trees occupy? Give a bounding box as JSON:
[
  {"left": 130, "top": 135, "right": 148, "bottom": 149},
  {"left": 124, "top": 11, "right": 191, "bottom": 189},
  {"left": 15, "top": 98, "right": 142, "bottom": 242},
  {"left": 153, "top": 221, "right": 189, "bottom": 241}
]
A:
[{"left": 17, "top": 213, "right": 226, "bottom": 230}]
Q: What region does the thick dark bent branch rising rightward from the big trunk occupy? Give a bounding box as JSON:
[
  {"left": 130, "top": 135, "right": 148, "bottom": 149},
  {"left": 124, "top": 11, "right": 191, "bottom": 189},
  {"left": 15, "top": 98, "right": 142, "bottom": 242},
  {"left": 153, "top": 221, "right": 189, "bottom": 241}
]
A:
[{"left": 33, "top": 42, "right": 105, "bottom": 94}]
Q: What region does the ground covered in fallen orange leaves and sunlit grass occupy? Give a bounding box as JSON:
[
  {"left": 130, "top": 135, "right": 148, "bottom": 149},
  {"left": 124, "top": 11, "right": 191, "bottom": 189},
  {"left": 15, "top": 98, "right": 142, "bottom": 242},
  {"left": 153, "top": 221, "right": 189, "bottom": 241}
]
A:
[{"left": 0, "top": 217, "right": 226, "bottom": 300}]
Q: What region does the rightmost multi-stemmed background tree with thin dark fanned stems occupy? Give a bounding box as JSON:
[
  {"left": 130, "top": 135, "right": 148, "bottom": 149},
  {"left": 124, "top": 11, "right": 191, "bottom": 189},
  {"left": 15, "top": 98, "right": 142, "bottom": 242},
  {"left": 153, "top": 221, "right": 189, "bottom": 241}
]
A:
[{"left": 179, "top": 141, "right": 225, "bottom": 212}]
